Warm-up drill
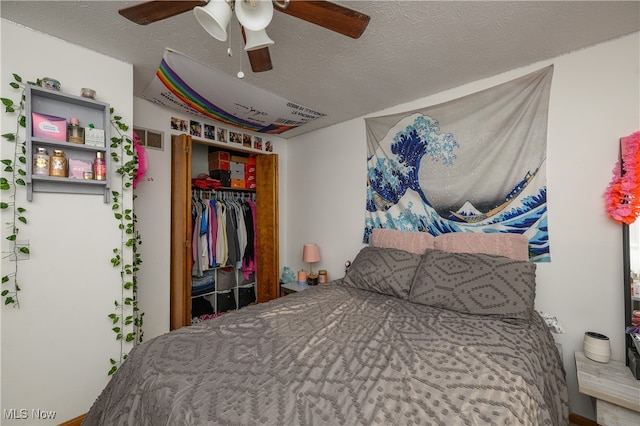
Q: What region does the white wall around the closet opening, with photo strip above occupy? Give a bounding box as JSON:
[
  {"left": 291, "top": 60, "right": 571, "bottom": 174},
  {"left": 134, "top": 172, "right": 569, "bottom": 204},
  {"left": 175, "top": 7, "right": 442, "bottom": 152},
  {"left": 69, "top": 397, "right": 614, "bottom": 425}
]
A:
[{"left": 133, "top": 98, "right": 287, "bottom": 340}]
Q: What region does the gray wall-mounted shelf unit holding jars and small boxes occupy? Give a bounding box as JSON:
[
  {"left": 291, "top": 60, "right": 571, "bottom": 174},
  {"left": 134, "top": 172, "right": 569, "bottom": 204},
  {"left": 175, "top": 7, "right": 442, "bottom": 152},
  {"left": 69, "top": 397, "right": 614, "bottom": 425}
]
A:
[{"left": 25, "top": 85, "right": 111, "bottom": 203}]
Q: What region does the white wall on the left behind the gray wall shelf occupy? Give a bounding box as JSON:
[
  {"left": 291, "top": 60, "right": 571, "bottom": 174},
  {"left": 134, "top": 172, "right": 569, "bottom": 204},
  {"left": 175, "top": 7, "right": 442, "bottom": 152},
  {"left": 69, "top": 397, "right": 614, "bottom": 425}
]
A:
[{"left": 0, "top": 20, "right": 133, "bottom": 425}]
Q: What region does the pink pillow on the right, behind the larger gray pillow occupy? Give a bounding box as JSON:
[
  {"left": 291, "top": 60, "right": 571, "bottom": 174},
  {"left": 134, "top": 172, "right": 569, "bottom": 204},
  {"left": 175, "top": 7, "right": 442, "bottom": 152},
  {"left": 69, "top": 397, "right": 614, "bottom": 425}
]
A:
[{"left": 435, "top": 232, "right": 529, "bottom": 261}]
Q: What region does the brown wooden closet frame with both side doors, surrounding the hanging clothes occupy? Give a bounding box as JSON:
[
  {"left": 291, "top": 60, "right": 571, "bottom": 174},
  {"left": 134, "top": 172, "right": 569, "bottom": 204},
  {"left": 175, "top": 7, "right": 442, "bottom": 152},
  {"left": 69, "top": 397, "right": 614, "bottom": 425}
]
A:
[{"left": 170, "top": 134, "right": 280, "bottom": 330}]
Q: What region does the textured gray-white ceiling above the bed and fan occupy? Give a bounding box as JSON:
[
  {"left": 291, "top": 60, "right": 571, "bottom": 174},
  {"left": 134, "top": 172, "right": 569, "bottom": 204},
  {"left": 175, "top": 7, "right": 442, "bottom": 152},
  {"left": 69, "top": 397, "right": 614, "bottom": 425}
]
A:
[{"left": 0, "top": 0, "right": 640, "bottom": 138}]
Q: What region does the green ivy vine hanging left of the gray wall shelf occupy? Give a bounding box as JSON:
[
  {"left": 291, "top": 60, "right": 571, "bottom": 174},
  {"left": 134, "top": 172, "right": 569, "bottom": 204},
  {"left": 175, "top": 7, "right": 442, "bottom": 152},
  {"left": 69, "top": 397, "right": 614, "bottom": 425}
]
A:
[{"left": 0, "top": 74, "right": 35, "bottom": 308}]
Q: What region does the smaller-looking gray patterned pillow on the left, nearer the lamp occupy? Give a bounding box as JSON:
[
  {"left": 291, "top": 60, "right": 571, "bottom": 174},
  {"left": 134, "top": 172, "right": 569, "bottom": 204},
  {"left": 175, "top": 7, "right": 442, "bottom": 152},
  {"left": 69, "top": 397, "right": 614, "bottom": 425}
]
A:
[{"left": 343, "top": 247, "right": 422, "bottom": 300}]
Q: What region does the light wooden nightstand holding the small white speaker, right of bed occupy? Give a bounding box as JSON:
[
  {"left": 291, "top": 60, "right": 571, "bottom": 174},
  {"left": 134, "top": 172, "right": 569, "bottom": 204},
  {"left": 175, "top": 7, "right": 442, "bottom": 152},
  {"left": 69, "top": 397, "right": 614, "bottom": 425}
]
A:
[{"left": 575, "top": 352, "right": 640, "bottom": 426}]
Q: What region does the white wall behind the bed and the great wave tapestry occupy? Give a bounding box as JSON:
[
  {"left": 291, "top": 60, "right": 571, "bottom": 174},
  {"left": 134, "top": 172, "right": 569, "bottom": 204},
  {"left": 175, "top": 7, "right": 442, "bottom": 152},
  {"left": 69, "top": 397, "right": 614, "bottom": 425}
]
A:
[{"left": 281, "top": 33, "right": 640, "bottom": 418}]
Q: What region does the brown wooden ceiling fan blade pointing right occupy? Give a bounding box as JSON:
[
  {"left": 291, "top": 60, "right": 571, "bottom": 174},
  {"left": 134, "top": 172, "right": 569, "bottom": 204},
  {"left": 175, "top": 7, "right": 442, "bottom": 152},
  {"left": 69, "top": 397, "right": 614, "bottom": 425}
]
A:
[{"left": 274, "top": 0, "right": 370, "bottom": 38}]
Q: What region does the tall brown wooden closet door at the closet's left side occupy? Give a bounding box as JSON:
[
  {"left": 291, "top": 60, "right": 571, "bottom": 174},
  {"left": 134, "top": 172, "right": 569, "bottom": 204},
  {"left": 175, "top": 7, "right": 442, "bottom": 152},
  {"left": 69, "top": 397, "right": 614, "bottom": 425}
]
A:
[{"left": 170, "top": 135, "right": 192, "bottom": 330}]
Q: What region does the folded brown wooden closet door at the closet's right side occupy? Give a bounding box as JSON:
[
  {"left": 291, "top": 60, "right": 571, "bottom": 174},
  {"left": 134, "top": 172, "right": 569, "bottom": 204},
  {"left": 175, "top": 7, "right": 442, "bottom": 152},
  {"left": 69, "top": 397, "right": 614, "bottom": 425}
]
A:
[{"left": 256, "top": 154, "right": 280, "bottom": 303}]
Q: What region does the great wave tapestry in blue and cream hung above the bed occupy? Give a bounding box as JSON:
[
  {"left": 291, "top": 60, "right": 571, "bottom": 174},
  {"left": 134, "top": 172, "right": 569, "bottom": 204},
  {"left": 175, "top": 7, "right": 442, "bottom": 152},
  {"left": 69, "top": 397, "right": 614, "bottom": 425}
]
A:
[{"left": 364, "top": 66, "right": 553, "bottom": 262}]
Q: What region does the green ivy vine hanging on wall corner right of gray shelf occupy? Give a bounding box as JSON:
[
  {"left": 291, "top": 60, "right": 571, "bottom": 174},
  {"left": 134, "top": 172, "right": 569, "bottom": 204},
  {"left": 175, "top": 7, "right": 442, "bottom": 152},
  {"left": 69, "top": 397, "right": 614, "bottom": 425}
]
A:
[{"left": 108, "top": 108, "right": 144, "bottom": 375}]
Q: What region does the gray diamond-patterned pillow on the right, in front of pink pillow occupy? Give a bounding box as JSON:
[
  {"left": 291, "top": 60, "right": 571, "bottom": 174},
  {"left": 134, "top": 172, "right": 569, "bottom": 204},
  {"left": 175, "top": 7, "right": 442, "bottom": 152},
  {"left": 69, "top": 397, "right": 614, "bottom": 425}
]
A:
[{"left": 409, "top": 250, "right": 536, "bottom": 321}]
